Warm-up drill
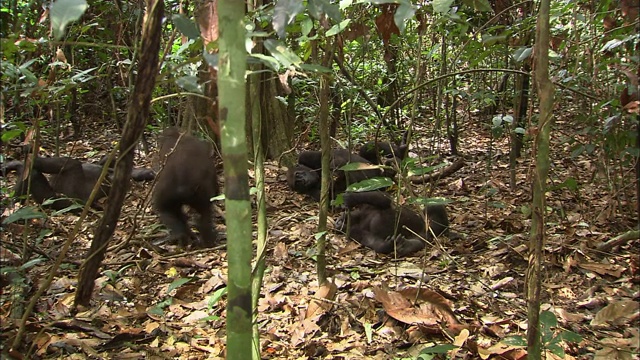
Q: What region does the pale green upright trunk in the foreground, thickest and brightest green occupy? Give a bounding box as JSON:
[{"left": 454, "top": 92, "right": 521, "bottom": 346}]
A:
[{"left": 218, "top": 0, "right": 253, "bottom": 360}]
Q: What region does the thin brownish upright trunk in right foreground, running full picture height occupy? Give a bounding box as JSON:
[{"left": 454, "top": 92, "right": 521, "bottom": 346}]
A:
[{"left": 526, "top": 0, "right": 554, "bottom": 359}]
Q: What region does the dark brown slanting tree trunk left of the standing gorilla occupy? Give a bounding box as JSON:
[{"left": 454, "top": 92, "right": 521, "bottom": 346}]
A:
[{"left": 75, "top": 0, "right": 164, "bottom": 306}]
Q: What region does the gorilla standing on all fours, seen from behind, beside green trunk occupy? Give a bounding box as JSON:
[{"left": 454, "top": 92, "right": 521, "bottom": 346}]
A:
[{"left": 153, "top": 127, "right": 218, "bottom": 247}]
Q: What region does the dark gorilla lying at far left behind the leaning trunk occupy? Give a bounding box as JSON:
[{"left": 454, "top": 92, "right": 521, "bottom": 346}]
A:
[{"left": 2, "top": 156, "right": 155, "bottom": 210}]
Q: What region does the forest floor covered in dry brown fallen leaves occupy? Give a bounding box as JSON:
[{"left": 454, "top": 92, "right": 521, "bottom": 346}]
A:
[{"left": 0, "top": 122, "right": 640, "bottom": 359}]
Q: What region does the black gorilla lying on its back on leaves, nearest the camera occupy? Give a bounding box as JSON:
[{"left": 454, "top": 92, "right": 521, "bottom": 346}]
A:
[{"left": 336, "top": 191, "right": 449, "bottom": 257}]
